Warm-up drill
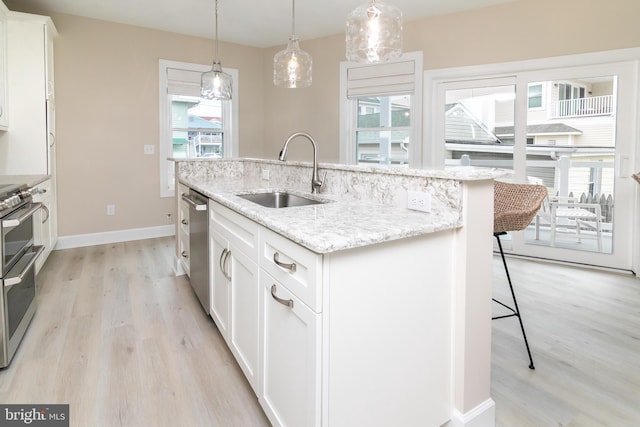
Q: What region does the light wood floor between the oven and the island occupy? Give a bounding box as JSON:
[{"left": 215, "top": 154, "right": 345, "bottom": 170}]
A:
[{"left": 0, "top": 238, "right": 270, "bottom": 427}]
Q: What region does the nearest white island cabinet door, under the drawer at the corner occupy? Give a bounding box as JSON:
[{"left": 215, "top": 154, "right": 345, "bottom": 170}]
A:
[{"left": 259, "top": 270, "right": 321, "bottom": 427}]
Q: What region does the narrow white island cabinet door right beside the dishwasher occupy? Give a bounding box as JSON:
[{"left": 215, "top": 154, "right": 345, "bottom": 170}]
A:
[{"left": 209, "top": 231, "right": 231, "bottom": 344}]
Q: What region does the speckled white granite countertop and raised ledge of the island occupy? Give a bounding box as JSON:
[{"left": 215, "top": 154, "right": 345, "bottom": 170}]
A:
[{"left": 176, "top": 159, "right": 505, "bottom": 254}]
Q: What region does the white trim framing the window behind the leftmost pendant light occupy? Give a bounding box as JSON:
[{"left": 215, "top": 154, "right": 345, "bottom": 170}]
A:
[{"left": 158, "top": 59, "right": 240, "bottom": 197}]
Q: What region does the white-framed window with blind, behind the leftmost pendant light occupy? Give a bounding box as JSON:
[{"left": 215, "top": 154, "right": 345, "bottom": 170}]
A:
[{"left": 159, "top": 60, "right": 238, "bottom": 197}]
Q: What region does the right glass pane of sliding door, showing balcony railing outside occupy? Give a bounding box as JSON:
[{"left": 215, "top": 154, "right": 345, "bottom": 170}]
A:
[{"left": 525, "top": 76, "right": 617, "bottom": 254}]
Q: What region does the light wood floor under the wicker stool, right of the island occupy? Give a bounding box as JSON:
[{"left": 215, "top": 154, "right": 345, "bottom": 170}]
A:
[{"left": 491, "top": 257, "right": 640, "bottom": 427}]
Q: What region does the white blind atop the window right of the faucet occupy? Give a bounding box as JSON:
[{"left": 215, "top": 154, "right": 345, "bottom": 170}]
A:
[{"left": 347, "top": 59, "right": 416, "bottom": 99}]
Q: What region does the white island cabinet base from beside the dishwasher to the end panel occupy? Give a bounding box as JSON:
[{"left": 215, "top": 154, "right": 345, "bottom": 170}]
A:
[{"left": 205, "top": 202, "right": 455, "bottom": 427}]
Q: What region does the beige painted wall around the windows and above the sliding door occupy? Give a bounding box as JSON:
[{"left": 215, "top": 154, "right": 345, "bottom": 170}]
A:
[{"left": 6, "top": 0, "right": 640, "bottom": 236}]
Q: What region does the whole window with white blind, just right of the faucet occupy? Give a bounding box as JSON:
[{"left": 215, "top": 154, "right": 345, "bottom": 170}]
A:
[{"left": 340, "top": 52, "right": 422, "bottom": 167}]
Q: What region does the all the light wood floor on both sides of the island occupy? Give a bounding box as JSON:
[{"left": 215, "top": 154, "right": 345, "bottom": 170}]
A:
[{"left": 0, "top": 238, "right": 640, "bottom": 427}]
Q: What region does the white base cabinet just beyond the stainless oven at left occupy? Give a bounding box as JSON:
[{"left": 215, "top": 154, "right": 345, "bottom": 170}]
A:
[{"left": 33, "top": 179, "right": 58, "bottom": 274}]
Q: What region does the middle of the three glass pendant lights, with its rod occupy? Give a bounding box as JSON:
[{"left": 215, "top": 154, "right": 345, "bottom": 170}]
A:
[{"left": 273, "top": 0, "right": 312, "bottom": 88}]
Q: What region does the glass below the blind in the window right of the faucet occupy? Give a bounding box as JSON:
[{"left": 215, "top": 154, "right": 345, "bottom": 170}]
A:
[{"left": 356, "top": 95, "right": 412, "bottom": 166}]
